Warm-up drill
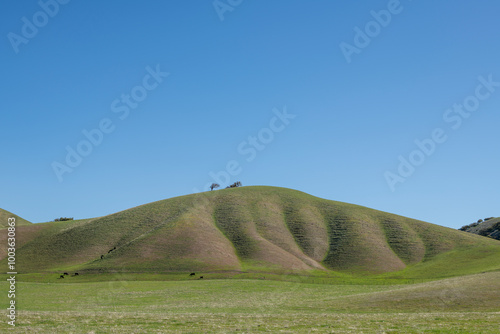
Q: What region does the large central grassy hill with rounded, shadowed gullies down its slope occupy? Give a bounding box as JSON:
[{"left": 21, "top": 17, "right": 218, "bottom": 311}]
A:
[{"left": 0, "top": 187, "right": 500, "bottom": 278}]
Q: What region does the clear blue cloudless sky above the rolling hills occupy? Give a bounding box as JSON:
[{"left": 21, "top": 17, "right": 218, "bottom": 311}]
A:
[{"left": 0, "top": 0, "right": 500, "bottom": 228}]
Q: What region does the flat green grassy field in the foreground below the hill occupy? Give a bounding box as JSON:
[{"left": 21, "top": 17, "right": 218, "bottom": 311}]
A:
[{"left": 0, "top": 272, "right": 500, "bottom": 333}]
